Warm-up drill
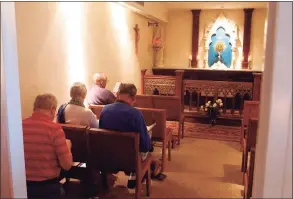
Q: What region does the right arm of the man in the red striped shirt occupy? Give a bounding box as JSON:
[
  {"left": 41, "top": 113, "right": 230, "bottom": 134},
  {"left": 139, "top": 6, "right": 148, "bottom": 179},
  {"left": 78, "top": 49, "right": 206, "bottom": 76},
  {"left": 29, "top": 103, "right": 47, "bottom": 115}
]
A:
[{"left": 53, "top": 127, "right": 72, "bottom": 171}]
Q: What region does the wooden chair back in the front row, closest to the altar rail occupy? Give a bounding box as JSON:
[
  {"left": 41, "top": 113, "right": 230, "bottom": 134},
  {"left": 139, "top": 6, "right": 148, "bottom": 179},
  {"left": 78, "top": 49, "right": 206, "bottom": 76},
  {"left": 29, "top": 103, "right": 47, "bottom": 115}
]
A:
[{"left": 152, "top": 95, "right": 182, "bottom": 121}]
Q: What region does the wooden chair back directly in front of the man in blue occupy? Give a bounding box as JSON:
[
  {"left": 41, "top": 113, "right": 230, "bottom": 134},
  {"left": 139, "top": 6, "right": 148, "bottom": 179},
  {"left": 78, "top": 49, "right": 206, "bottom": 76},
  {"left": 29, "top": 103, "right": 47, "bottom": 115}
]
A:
[{"left": 137, "top": 108, "right": 166, "bottom": 140}]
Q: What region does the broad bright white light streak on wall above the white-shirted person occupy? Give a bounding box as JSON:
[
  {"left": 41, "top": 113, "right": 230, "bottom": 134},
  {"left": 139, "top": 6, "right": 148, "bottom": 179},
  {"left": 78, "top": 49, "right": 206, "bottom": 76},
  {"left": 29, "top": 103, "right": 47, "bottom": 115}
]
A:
[{"left": 59, "top": 2, "right": 85, "bottom": 84}]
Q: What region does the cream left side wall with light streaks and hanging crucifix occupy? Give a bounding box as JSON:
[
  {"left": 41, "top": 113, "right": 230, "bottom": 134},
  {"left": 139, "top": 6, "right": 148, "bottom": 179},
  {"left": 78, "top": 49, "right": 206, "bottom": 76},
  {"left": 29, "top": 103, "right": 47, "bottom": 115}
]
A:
[{"left": 16, "top": 2, "right": 153, "bottom": 117}]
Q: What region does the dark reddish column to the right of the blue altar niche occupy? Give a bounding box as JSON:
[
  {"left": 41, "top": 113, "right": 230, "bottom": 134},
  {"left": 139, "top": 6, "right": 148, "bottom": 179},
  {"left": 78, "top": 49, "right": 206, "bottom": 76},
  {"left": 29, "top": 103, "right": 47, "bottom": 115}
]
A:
[{"left": 242, "top": 8, "right": 254, "bottom": 69}]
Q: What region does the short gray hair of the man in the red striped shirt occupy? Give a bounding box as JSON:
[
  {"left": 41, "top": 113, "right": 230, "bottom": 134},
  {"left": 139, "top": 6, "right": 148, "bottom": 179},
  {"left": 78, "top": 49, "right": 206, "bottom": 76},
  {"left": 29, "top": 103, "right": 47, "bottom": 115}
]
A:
[{"left": 34, "top": 93, "right": 57, "bottom": 111}]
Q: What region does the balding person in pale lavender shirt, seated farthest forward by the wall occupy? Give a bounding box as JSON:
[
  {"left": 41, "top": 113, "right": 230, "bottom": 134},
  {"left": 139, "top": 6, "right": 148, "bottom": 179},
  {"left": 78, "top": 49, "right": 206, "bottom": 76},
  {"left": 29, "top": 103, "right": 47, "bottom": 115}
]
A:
[{"left": 87, "top": 73, "right": 116, "bottom": 105}]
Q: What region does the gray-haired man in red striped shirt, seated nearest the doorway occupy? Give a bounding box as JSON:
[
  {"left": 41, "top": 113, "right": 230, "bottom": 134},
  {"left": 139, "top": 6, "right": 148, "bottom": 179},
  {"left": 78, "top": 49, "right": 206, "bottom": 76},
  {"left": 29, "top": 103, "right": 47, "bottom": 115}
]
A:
[{"left": 22, "top": 94, "right": 72, "bottom": 198}]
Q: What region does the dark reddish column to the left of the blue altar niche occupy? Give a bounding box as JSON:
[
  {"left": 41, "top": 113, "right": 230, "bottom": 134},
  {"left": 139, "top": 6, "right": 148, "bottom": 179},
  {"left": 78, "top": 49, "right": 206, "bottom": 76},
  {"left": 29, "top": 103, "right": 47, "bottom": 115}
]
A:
[{"left": 191, "top": 10, "right": 201, "bottom": 68}]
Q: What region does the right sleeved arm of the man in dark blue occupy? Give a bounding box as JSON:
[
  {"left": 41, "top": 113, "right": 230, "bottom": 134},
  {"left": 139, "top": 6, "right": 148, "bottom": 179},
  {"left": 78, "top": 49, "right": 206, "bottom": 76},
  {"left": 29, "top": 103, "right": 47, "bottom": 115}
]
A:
[{"left": 135, "top": 111, "right": 152, "bottom": 152}]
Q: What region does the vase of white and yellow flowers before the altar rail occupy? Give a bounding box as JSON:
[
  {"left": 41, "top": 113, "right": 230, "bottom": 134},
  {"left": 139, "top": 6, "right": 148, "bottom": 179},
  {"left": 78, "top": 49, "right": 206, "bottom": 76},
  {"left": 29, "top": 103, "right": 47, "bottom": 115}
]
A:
[{"left": 201, "top": 99, "right": 223, "bottom": 126}]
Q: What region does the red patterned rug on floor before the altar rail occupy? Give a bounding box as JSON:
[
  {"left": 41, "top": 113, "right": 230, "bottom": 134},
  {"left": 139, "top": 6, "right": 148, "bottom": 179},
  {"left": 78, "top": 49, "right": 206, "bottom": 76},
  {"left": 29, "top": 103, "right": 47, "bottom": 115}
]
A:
[{"left": 167, "top": 122, "right": 241, "bottom": 142}]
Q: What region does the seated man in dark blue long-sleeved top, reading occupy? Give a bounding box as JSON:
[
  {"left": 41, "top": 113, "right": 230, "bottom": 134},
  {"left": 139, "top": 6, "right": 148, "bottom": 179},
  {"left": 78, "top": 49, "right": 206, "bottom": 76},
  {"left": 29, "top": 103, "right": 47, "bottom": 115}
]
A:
[{"left": 99, "top": 84, "right": 163, "bottom": 188}]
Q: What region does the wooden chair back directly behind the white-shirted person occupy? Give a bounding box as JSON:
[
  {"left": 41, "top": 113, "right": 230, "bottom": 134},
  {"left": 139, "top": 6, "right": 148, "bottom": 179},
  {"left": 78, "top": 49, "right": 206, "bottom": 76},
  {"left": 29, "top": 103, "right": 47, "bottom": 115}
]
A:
[{"left": 61, "top": 124, "right": 87, "bottom": 163}]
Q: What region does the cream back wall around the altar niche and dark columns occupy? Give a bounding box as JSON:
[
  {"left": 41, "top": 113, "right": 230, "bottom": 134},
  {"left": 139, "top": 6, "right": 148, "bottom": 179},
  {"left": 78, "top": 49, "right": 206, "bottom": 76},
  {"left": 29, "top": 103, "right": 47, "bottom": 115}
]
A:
[{"left": 164, "top": 9, "right": 266, "bottom": 70}]
